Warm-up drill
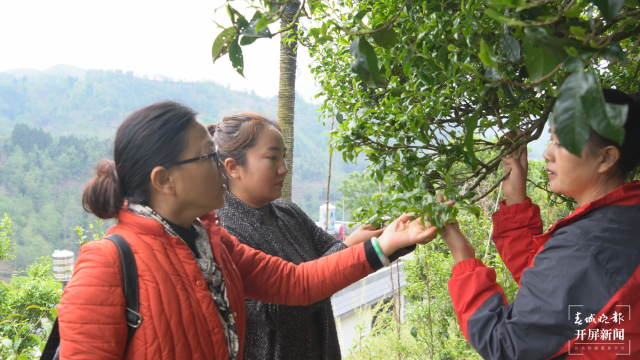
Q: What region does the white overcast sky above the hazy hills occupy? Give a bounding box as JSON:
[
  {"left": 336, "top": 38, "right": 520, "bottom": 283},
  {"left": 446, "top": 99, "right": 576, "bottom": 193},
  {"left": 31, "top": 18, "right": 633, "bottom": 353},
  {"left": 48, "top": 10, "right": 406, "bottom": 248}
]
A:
[{"left": 0, "top": 0, "right": 316, "bottom": 100}]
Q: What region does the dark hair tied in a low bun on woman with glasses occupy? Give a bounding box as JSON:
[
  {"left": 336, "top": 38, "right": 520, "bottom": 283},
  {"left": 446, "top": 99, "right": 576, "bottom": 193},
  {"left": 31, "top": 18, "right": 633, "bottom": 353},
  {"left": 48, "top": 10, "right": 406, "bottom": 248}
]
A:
[{"left": 82, "top": 101, "right": 197, "bottom": 219}]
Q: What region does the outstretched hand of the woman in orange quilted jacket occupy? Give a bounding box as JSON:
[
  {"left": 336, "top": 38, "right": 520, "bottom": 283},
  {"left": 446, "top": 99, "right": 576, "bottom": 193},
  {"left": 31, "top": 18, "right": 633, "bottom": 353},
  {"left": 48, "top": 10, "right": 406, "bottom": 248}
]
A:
[{"left": 378, "top": 215, "right": 437, "bottom": 256}]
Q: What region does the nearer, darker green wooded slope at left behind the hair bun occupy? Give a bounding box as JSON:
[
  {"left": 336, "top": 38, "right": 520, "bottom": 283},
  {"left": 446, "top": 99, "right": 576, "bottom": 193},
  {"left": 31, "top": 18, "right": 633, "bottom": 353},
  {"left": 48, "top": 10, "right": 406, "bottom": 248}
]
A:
[{"left": 0, "top": 124, "right": 112, "bottom": 268}]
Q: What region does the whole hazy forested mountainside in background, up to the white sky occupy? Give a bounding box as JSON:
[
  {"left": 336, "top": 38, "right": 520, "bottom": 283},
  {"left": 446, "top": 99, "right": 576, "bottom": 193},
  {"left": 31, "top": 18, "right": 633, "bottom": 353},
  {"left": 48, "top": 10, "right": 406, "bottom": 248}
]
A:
[{"left": 0, "top": 69, "right": 363, "bottom": 268}]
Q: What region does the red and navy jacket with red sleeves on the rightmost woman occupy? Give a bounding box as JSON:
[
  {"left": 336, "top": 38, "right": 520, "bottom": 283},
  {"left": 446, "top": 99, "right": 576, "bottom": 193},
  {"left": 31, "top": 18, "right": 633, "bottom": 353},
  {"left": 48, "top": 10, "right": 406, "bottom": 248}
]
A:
[{"left": 449, "top": 181, "right": 640, "bottom": 359}]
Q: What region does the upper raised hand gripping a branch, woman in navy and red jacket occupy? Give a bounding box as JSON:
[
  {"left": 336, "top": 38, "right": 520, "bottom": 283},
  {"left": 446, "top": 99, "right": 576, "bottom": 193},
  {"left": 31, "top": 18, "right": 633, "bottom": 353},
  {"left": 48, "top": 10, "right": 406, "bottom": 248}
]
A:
[{"left": 502, "top": 132, "right": 529, "bottom": 205}]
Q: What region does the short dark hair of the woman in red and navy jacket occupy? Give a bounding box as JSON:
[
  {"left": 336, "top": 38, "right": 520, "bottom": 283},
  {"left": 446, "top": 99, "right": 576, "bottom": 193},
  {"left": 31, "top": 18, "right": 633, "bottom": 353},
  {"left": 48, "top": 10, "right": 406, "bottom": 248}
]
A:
[{"left": 587, "top": 89, "right": 640, "bottom": 178}]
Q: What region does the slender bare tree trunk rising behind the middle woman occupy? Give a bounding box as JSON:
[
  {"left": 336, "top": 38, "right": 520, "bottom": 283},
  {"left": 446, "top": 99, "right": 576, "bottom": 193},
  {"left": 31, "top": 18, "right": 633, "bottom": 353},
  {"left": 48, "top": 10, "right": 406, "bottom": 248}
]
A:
[{"left": 278, "top": 0, "right": 300, "bottom": 200}]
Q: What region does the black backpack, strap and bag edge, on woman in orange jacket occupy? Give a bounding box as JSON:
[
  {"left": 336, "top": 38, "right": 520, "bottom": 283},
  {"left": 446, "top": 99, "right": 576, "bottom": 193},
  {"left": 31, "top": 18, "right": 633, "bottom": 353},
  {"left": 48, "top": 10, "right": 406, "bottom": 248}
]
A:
[{"left": 40, "top": 234, "right": 142, "bottom": 360}]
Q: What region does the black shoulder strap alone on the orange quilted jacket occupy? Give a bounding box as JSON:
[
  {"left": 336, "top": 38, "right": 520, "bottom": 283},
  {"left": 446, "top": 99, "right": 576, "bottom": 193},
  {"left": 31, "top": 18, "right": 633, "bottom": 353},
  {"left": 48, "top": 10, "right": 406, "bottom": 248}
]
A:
[{"left": 105, "top": 234, "right": 142, "bottom": 351}]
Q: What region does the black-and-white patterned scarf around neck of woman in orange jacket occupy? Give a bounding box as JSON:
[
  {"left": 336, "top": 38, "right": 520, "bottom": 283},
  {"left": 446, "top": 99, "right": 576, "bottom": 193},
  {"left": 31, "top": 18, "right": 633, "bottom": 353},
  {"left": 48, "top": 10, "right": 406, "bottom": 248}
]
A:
[{"left": 128, "top": 202, "right": 240, "bottom": 360}]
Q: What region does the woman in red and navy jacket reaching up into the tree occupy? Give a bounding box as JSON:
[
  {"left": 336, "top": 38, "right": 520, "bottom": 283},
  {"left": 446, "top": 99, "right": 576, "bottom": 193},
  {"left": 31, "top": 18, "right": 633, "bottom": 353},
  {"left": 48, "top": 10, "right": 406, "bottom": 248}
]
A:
[{"left": 443, "top": 89, "right": 640, "bottom": 359}]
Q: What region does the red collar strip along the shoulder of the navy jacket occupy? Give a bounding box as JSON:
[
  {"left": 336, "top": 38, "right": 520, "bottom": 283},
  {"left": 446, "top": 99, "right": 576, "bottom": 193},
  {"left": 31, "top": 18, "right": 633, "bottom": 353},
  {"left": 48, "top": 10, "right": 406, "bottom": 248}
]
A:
[{"left": 546, "top": 181, "right": 640, "bottom": 234}]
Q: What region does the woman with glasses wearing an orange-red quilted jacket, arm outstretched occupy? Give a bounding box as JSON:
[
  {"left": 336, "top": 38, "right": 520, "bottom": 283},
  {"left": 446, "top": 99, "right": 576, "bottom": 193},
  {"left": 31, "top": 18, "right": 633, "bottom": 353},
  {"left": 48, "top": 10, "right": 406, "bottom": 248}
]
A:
[{"left": 58, "top": 102, "right": 435, "bottom": 360}]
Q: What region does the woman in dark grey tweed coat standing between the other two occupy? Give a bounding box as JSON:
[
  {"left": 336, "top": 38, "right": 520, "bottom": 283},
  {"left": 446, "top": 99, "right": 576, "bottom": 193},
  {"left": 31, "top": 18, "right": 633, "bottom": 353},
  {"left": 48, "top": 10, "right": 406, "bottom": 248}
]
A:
[{"left": 208, "top": 113, "right": 413, "bottom": 360}]
